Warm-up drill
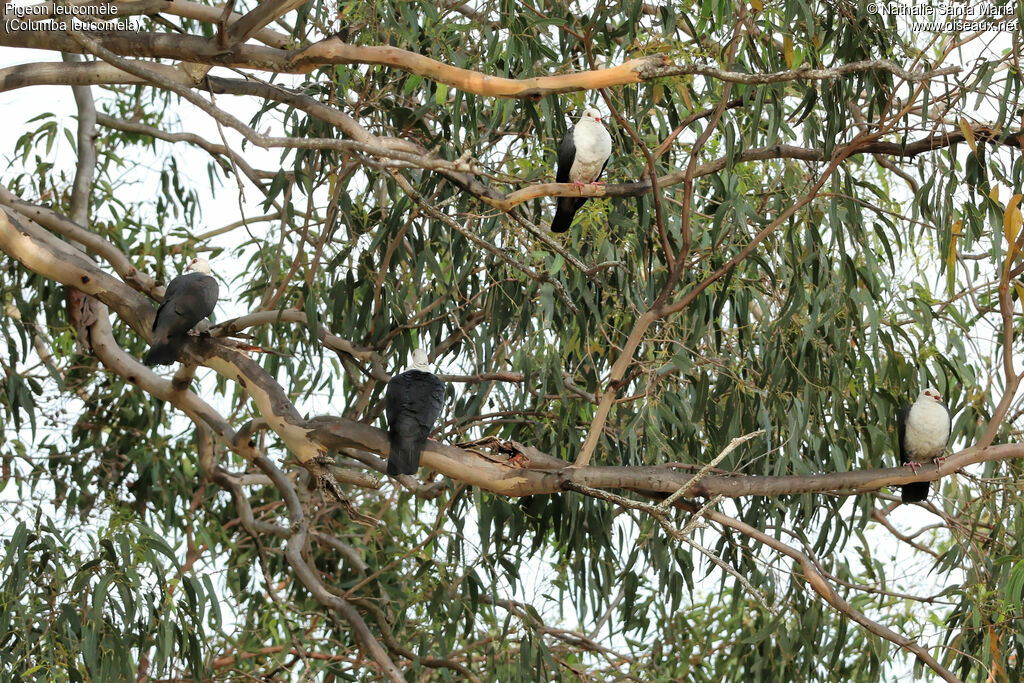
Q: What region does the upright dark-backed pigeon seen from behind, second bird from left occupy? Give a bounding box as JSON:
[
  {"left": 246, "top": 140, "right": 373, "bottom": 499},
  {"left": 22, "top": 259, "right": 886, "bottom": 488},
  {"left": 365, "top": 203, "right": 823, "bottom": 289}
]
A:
[{"left": 385, "top": 349, "right": 444, "bottom": 476}]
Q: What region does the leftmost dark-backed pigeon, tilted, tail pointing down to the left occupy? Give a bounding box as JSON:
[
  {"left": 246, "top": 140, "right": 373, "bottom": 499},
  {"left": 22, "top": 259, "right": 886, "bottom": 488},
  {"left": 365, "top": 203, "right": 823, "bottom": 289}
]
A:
[{"left": 142, "top": 258, "right": 219, "bottom": 366}]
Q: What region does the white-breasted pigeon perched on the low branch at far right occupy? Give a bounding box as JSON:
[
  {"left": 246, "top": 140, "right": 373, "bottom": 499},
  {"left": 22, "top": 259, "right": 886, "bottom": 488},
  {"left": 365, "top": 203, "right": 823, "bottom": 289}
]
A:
[{"left": 897, "top": 387, "right": 950, "bottom": 503}]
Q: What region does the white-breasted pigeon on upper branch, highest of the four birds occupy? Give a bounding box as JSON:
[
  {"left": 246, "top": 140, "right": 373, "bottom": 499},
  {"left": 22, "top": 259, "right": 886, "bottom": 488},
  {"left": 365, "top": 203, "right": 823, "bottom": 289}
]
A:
[{"left": 551, "top": 109, "right": 611, "bottom": 232}]
